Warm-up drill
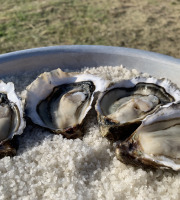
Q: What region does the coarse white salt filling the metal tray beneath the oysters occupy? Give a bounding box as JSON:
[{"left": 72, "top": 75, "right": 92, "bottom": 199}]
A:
[{"left": 0, "top": 67, "right": 180, "bottom": 200}]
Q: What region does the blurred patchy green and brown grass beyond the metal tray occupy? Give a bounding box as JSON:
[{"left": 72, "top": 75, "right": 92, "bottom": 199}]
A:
[{"left": 0, "top": 0, "right": 180, "bottom": 58}]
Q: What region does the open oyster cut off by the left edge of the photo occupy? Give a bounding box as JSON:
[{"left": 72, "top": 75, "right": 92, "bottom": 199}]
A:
[{"left": 0, "top": 81, "right": 26, "bottom": 158}]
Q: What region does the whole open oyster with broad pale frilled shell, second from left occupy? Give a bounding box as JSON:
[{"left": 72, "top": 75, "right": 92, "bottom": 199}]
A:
[{"left": 26, "top": 69, "right": 107, "bottom": 138}]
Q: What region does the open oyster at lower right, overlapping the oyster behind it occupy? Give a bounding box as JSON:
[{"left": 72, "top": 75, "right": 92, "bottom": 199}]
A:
[{"left": 116, "top": 102, "right": 180, "bottom": 170}]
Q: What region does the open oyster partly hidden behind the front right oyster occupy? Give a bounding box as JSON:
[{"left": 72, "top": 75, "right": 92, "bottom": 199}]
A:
[{"left": 96, "top": 78, "right": 180, "bottom": 141}]
